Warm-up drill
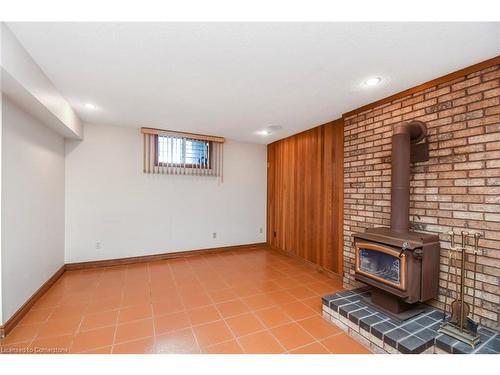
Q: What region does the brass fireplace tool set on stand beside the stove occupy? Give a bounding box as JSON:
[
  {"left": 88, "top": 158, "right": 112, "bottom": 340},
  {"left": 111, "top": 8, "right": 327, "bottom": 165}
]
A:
[{"left": 439, "top": 231, "right": 481, "bottom": 348}]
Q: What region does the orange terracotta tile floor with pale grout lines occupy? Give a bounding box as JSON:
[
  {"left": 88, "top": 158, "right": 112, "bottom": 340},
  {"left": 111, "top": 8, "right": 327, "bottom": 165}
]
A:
[{"left": 0, "top": 246, "right": 369, "bottom": 354}]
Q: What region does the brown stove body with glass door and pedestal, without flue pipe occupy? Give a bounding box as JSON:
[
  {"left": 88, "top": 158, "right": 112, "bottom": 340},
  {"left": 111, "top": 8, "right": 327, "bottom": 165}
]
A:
[{"left": 354, "top": 228, "right": 439, "bottom": 319}]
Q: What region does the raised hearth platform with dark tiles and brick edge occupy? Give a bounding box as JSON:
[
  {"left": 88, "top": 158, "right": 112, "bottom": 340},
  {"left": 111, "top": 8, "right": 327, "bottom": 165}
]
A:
[{"left": 323, "top": 288, "right": 500, "bottom": 354}]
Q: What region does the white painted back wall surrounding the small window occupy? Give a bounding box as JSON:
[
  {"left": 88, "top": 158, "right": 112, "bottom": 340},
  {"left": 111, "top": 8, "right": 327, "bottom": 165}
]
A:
[{"left": 66, "top": 124, "right": 267, "bottom": 263}]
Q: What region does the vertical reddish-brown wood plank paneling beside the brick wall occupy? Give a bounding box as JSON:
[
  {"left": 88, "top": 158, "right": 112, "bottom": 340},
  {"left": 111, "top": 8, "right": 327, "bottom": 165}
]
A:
[{"left": 267, "top": 119, "right": 344, "bottom": 274}]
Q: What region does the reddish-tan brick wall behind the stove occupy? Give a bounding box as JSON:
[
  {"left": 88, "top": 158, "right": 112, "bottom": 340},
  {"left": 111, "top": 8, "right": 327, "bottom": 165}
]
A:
[{"left": 344, "top": 65, "right": 500, "bottom": 329}]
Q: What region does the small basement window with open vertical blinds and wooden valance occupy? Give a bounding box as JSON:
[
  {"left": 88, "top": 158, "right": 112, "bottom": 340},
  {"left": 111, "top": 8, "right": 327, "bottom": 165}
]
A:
[{"left": 141, "top": 128, "right": 225, "bottom": 181}]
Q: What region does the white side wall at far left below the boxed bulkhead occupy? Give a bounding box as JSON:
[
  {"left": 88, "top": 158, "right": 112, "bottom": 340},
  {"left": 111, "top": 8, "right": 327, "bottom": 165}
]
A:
[{"left": 1, "top": 96, "right": 64, "bottom": 322}]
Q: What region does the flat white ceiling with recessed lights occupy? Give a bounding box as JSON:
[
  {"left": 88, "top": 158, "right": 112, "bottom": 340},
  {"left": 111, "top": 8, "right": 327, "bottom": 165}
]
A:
[{"left": 8, "top": 23, "right": 500, "bottom": 143}]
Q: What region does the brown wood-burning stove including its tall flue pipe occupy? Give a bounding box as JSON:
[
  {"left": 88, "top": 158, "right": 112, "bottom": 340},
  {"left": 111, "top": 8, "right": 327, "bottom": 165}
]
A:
[{"left": 353, "top": 121, "right": 440, "bottom": 319}]
